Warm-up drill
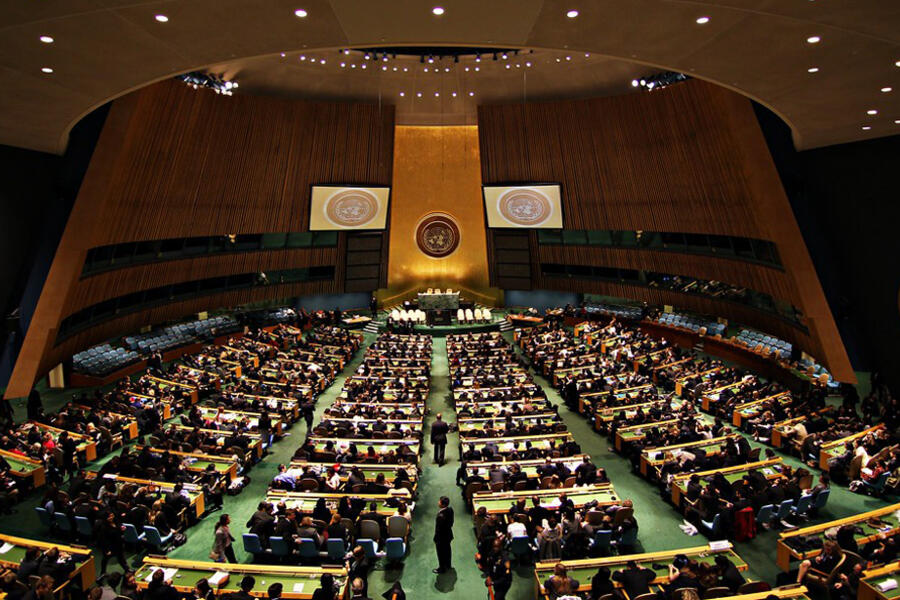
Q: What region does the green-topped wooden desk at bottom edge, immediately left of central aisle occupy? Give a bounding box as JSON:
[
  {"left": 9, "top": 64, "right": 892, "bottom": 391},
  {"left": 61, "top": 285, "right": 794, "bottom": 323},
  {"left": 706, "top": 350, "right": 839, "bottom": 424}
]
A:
[{"left": 135, "top": 556, "right": 348, "bottom": 600}]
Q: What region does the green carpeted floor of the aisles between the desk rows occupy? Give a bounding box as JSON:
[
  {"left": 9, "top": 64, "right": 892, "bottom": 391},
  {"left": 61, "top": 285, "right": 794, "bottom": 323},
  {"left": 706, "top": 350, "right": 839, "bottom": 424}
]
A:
[{"left": 0, "top": 334, "right": 886, "bottom": 600}]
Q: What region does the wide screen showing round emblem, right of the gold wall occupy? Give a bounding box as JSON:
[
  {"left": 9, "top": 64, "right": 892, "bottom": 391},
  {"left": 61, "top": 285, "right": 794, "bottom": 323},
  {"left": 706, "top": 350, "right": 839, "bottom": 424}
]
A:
[{"left": 483, "top": 184, "right": 563, "bottom": 229}]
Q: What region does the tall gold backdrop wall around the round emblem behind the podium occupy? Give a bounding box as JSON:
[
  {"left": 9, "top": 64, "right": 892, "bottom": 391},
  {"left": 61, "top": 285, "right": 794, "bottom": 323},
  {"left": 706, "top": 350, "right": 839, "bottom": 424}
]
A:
[{"left": 379, "top": 127, "right": 501, "bottom": 305}]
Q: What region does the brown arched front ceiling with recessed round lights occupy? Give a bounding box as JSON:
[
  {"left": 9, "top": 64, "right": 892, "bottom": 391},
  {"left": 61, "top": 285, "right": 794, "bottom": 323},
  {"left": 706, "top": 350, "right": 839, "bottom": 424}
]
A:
[{"left": 0, "top": 0, "right": 900, "bottom": 152}]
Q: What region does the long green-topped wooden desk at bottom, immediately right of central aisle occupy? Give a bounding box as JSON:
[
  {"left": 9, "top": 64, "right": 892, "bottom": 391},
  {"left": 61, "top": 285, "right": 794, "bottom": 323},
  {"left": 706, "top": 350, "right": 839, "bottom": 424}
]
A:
[{"left": 534, "top": 545, "right": 748, "bottom": 599}]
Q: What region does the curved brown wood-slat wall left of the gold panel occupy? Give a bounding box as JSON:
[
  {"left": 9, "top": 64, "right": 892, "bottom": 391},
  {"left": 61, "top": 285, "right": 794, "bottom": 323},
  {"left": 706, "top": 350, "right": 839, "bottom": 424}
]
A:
[{"left": 6, "top": 81, "right": 394, "bottom": 397}]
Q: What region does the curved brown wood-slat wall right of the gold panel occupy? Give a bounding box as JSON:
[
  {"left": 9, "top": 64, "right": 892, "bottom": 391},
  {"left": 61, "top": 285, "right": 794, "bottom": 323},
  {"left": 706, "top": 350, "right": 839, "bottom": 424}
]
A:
[{"left": 478, "top": 80, "right": 854, "bottom": 381}]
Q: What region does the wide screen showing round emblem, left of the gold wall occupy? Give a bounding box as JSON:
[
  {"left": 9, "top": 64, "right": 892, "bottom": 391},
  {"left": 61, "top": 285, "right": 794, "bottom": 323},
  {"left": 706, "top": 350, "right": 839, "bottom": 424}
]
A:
[{"left": 309, "top": 185, "right": 391, "bottom": 231}]
